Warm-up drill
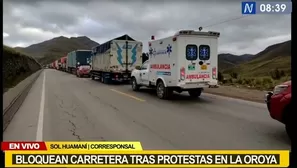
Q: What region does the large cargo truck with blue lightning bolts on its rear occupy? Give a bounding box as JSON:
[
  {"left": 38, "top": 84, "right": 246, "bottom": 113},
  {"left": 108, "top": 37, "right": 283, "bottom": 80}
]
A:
[{"left": 90, "top": 34, "right": 142, "bottom": 84}]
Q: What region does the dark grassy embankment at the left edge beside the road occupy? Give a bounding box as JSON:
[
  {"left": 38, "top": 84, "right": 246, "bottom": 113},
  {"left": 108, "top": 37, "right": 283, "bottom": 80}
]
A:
[{"left": 2, "top": 46, "right": 41, "bottom": 92}]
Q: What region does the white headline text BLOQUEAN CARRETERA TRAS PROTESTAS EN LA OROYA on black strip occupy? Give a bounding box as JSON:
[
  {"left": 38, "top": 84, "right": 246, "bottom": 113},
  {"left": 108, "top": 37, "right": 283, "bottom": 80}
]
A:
[{"left": 12, "top": 154, "right": 280, "bottom": 165}]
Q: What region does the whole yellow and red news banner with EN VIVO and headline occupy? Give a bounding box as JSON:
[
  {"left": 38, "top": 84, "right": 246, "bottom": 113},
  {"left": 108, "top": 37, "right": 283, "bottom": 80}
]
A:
[{"left": 2, "top": 142, "right": 289, "bottom": 167}]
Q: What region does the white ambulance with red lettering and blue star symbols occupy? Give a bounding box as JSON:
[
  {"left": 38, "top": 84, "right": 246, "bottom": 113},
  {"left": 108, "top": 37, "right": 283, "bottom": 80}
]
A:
[{"left": 131, "top": 30, "right": 220, "bottom": 99}]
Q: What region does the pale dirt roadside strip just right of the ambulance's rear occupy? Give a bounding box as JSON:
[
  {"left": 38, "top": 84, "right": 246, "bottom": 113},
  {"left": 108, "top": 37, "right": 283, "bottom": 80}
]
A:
[{"left": 204, "top": 86, "right": 266, "bottom": 103}]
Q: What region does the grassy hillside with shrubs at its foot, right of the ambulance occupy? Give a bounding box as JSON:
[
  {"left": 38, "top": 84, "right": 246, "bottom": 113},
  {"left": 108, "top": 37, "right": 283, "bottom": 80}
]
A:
[{"left": 220, "top": 41, "right": 291, "bottom": 90}]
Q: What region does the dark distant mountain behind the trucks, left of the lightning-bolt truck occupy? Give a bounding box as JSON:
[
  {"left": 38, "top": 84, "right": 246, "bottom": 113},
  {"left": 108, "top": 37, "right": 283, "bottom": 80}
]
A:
[{"left": 14, "top": 36, "right": 99, "bottom": 64}]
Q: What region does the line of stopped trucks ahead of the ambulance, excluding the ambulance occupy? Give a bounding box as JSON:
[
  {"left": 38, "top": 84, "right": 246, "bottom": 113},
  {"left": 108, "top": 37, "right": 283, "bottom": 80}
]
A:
[{"left": 49, "top": 35, "right": 148, "bottom": 79}]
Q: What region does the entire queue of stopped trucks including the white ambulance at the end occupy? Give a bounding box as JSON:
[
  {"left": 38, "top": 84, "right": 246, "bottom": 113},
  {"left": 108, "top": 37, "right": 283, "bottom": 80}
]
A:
[{"left": 51, "top": 30, "right": 220, "bottom": 99}]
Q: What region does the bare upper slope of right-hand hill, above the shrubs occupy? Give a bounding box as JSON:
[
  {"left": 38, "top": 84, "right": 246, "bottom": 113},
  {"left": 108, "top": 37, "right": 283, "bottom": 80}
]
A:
[{"left": 222, "top": 40, "right": 291, "bottom": 77}]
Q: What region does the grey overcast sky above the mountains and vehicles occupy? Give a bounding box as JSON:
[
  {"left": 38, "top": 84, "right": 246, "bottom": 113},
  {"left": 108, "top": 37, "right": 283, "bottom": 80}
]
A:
[{"left": 3, "top": 0, "right": 291, "bottom": 54}]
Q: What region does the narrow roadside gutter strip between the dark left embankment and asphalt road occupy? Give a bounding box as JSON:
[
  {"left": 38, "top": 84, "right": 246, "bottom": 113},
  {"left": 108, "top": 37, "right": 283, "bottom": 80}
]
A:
[{"left": 3, "top": 69, "right": 43, "bottom": 132}]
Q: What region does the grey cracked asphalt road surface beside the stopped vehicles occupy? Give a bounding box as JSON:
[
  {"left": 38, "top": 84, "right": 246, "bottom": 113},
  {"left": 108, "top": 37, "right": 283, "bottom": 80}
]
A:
[{"left": 4, "top": 69, "right": 290, "bottom": 150}]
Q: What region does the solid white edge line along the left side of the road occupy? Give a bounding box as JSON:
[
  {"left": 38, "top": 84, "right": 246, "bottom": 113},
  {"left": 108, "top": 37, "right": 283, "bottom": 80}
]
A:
[{"left": 36, "top": 71, "right": 45, "bottom": 141}]
